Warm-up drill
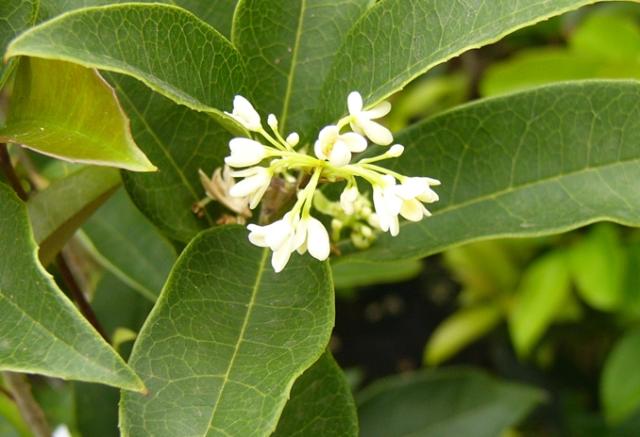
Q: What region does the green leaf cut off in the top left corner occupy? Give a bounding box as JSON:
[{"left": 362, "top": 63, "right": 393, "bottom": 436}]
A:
[{"left": 0, "top": 0, "right": 39, "bottom": 89}]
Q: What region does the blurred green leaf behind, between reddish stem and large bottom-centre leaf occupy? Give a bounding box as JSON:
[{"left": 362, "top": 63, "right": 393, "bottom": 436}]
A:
[{"left": 82, "top": 190, "right": 176, "bottom": 302}]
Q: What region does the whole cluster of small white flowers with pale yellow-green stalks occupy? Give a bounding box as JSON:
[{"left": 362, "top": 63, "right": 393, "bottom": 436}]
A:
[{"left": 201, "top": 92, "right": 440, "bottom": 272}]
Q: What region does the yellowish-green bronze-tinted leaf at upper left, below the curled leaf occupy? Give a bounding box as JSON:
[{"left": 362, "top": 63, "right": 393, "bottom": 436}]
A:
[{"left": 0, "top": 58, "right": 156, "bottom": 171}]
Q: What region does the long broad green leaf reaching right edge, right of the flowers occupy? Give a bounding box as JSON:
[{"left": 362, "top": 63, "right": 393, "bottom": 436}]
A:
[{"left": 342, "top": 81, "right": 640, "bottom": 261}]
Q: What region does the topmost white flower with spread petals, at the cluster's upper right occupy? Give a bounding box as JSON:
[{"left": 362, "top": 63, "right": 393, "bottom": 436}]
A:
[{"left": 347, "top": 91, "right": 393, "bottom": 146}]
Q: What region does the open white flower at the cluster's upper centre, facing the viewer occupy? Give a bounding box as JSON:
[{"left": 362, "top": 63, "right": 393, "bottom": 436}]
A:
[{"left": 314, "top": 125, "right": 367, "bottom": 167}]
